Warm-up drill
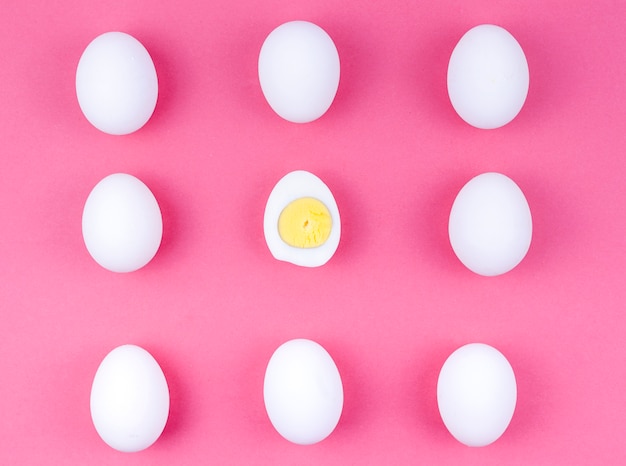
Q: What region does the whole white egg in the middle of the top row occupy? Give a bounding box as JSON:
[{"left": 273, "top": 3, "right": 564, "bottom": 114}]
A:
[{"left": 259, "top": 21, "right": 339, "bottom": 123}]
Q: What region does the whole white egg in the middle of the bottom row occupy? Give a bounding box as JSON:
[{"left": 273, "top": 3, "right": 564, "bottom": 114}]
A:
[{"left": 263, "top": 339, "right": 343, "bottom": 445}]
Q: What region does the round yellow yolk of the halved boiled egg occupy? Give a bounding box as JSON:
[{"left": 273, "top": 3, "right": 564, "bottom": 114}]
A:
[{"left": 278, "top": 197, "right": 333, "bottom": 248}]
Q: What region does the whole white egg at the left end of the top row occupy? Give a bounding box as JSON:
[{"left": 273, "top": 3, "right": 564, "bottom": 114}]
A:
[{"left": 76, "top": 32, "right": 159, "bottom": 135}]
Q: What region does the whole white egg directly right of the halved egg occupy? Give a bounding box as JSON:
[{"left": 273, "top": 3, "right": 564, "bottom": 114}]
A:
[{"left": 448, "top": 173, "right": 532, "bottom": 276}]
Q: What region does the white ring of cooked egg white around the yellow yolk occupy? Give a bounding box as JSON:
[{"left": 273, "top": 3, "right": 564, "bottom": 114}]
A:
[{"left": 263, "top": 170, "right": 341, "bottom": 267}]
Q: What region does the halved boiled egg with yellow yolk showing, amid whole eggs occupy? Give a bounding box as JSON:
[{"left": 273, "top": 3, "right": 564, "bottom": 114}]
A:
[{"left": 263, "top": 170, "right": 341, "bottom": 267}]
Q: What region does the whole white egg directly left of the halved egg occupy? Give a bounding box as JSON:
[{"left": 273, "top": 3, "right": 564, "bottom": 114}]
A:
[{"left": 82, "top": 173, "right": 163, "bottom": 272}]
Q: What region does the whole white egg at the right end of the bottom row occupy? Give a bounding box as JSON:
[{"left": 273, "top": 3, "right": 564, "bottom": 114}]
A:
[{"left": 437, "top": 343, "right": 517, "bottom": 447}]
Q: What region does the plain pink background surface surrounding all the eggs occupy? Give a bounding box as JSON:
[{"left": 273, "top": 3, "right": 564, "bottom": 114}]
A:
[{"left": 0, "top": 0, "right": 626, "bottom": 465}]
